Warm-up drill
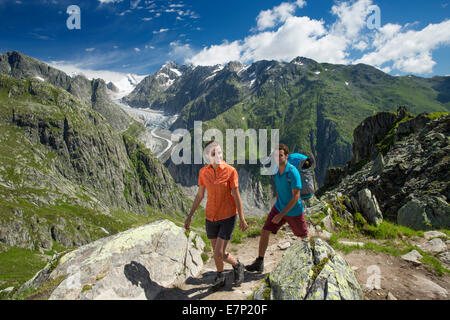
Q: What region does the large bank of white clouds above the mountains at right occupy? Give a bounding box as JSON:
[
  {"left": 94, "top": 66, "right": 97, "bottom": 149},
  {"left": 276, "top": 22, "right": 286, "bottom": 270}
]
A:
[{"left": 185, "top": 0, "right": 450, "bottom": 74}]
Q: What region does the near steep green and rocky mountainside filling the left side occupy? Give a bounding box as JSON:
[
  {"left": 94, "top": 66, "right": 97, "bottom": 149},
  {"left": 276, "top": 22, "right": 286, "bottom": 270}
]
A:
[{"left": 0, "top": 75, "right": 186, "bottom": 249}]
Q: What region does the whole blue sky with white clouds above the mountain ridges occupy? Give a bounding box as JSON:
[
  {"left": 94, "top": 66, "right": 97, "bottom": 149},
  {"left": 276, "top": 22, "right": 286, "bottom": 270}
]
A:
[{"left": 0, "top": 0, "right": 450, "bottom": 77}]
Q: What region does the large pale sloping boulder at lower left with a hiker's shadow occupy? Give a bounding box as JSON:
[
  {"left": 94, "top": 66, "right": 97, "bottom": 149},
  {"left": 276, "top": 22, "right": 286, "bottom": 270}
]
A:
[{"left": 15, "top": 220, "right": 205, "bottom": 300}]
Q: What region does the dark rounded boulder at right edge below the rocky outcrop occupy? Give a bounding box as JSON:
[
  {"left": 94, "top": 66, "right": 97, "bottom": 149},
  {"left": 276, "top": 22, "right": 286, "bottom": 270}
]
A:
[{"left": 397, "top": 196, "right": 450, "bottom": 230}]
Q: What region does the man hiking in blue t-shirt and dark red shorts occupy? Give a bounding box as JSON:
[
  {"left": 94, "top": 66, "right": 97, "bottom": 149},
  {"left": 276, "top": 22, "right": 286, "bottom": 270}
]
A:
[{"left": 245, "top": 144, "right": 308, "bottom": 273}]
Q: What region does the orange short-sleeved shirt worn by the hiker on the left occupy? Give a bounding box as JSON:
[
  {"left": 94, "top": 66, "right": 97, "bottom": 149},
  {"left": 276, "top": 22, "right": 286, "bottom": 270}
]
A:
[{"left": 198, "top": 161, "right": 239, "bottom": 221}]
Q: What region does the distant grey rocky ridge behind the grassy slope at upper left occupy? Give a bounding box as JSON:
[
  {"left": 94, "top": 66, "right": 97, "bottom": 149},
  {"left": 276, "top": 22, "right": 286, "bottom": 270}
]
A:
[{"left": 0, "top": 51, "right": 132, "bottom": 131}]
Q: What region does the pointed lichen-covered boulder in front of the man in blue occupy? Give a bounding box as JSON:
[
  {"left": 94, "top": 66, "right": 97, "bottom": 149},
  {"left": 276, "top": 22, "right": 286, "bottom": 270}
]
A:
[{"left": 253, "top": 238, "right": 362, "bottom": 300}]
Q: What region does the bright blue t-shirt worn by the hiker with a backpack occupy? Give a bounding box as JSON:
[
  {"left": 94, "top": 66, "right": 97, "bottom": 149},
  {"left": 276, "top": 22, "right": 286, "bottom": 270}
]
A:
[{"left": 275, "top": 163, "right": 303, "bottom": 217}]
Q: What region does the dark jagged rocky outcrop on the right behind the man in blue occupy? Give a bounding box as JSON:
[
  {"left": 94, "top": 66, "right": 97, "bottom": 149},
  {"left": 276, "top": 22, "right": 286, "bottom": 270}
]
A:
[{"left": 321, "top": 113, "right": 450, "bottom": 229}]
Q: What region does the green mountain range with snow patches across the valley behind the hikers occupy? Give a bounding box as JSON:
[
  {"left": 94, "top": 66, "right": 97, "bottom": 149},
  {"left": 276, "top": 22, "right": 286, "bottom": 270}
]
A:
[{"left": 123, "top": 57, "right": 450, "bottom": 192}]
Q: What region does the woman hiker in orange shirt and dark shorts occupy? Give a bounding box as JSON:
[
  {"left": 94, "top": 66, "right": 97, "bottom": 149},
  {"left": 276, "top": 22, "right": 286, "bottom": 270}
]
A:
[{"left": 184, "top": 141, "right": 248, "bottom": 290}]
